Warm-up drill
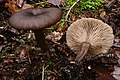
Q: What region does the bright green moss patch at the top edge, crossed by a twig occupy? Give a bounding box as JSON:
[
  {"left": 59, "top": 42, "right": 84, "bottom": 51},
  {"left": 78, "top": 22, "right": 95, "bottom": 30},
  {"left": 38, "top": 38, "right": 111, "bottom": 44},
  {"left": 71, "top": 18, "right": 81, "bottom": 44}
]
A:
[{"left": 66, "top": 0, "right": 104, "bottom": 11}]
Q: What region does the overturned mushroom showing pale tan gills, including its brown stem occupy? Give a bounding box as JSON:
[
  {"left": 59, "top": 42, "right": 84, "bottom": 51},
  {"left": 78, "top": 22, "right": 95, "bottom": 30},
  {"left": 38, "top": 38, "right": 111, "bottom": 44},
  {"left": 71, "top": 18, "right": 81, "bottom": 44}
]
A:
[{"left": 66, "top": 18, "right": 114, "bottom": 62}]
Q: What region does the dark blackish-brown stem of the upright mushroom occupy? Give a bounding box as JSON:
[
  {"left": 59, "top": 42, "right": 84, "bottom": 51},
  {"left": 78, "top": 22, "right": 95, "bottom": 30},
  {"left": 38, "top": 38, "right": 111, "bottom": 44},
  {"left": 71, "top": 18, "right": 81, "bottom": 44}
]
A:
[{"left": 33, "top": 29, "right": 49, "bottom": 51}]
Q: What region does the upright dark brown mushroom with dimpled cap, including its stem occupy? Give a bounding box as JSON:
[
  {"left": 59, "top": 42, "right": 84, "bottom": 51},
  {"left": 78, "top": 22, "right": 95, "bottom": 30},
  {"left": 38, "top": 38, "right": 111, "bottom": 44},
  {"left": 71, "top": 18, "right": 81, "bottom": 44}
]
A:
[{"left": 8, "top": 8, "right": 62, "bottom": 50}]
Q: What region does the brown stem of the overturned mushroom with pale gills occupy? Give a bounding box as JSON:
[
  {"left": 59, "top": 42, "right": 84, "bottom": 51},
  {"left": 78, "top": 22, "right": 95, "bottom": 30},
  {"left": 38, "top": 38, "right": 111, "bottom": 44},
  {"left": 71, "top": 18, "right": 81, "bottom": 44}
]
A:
[{"left": 75, "top": 42, "right": 90, "bottom": 62}]
